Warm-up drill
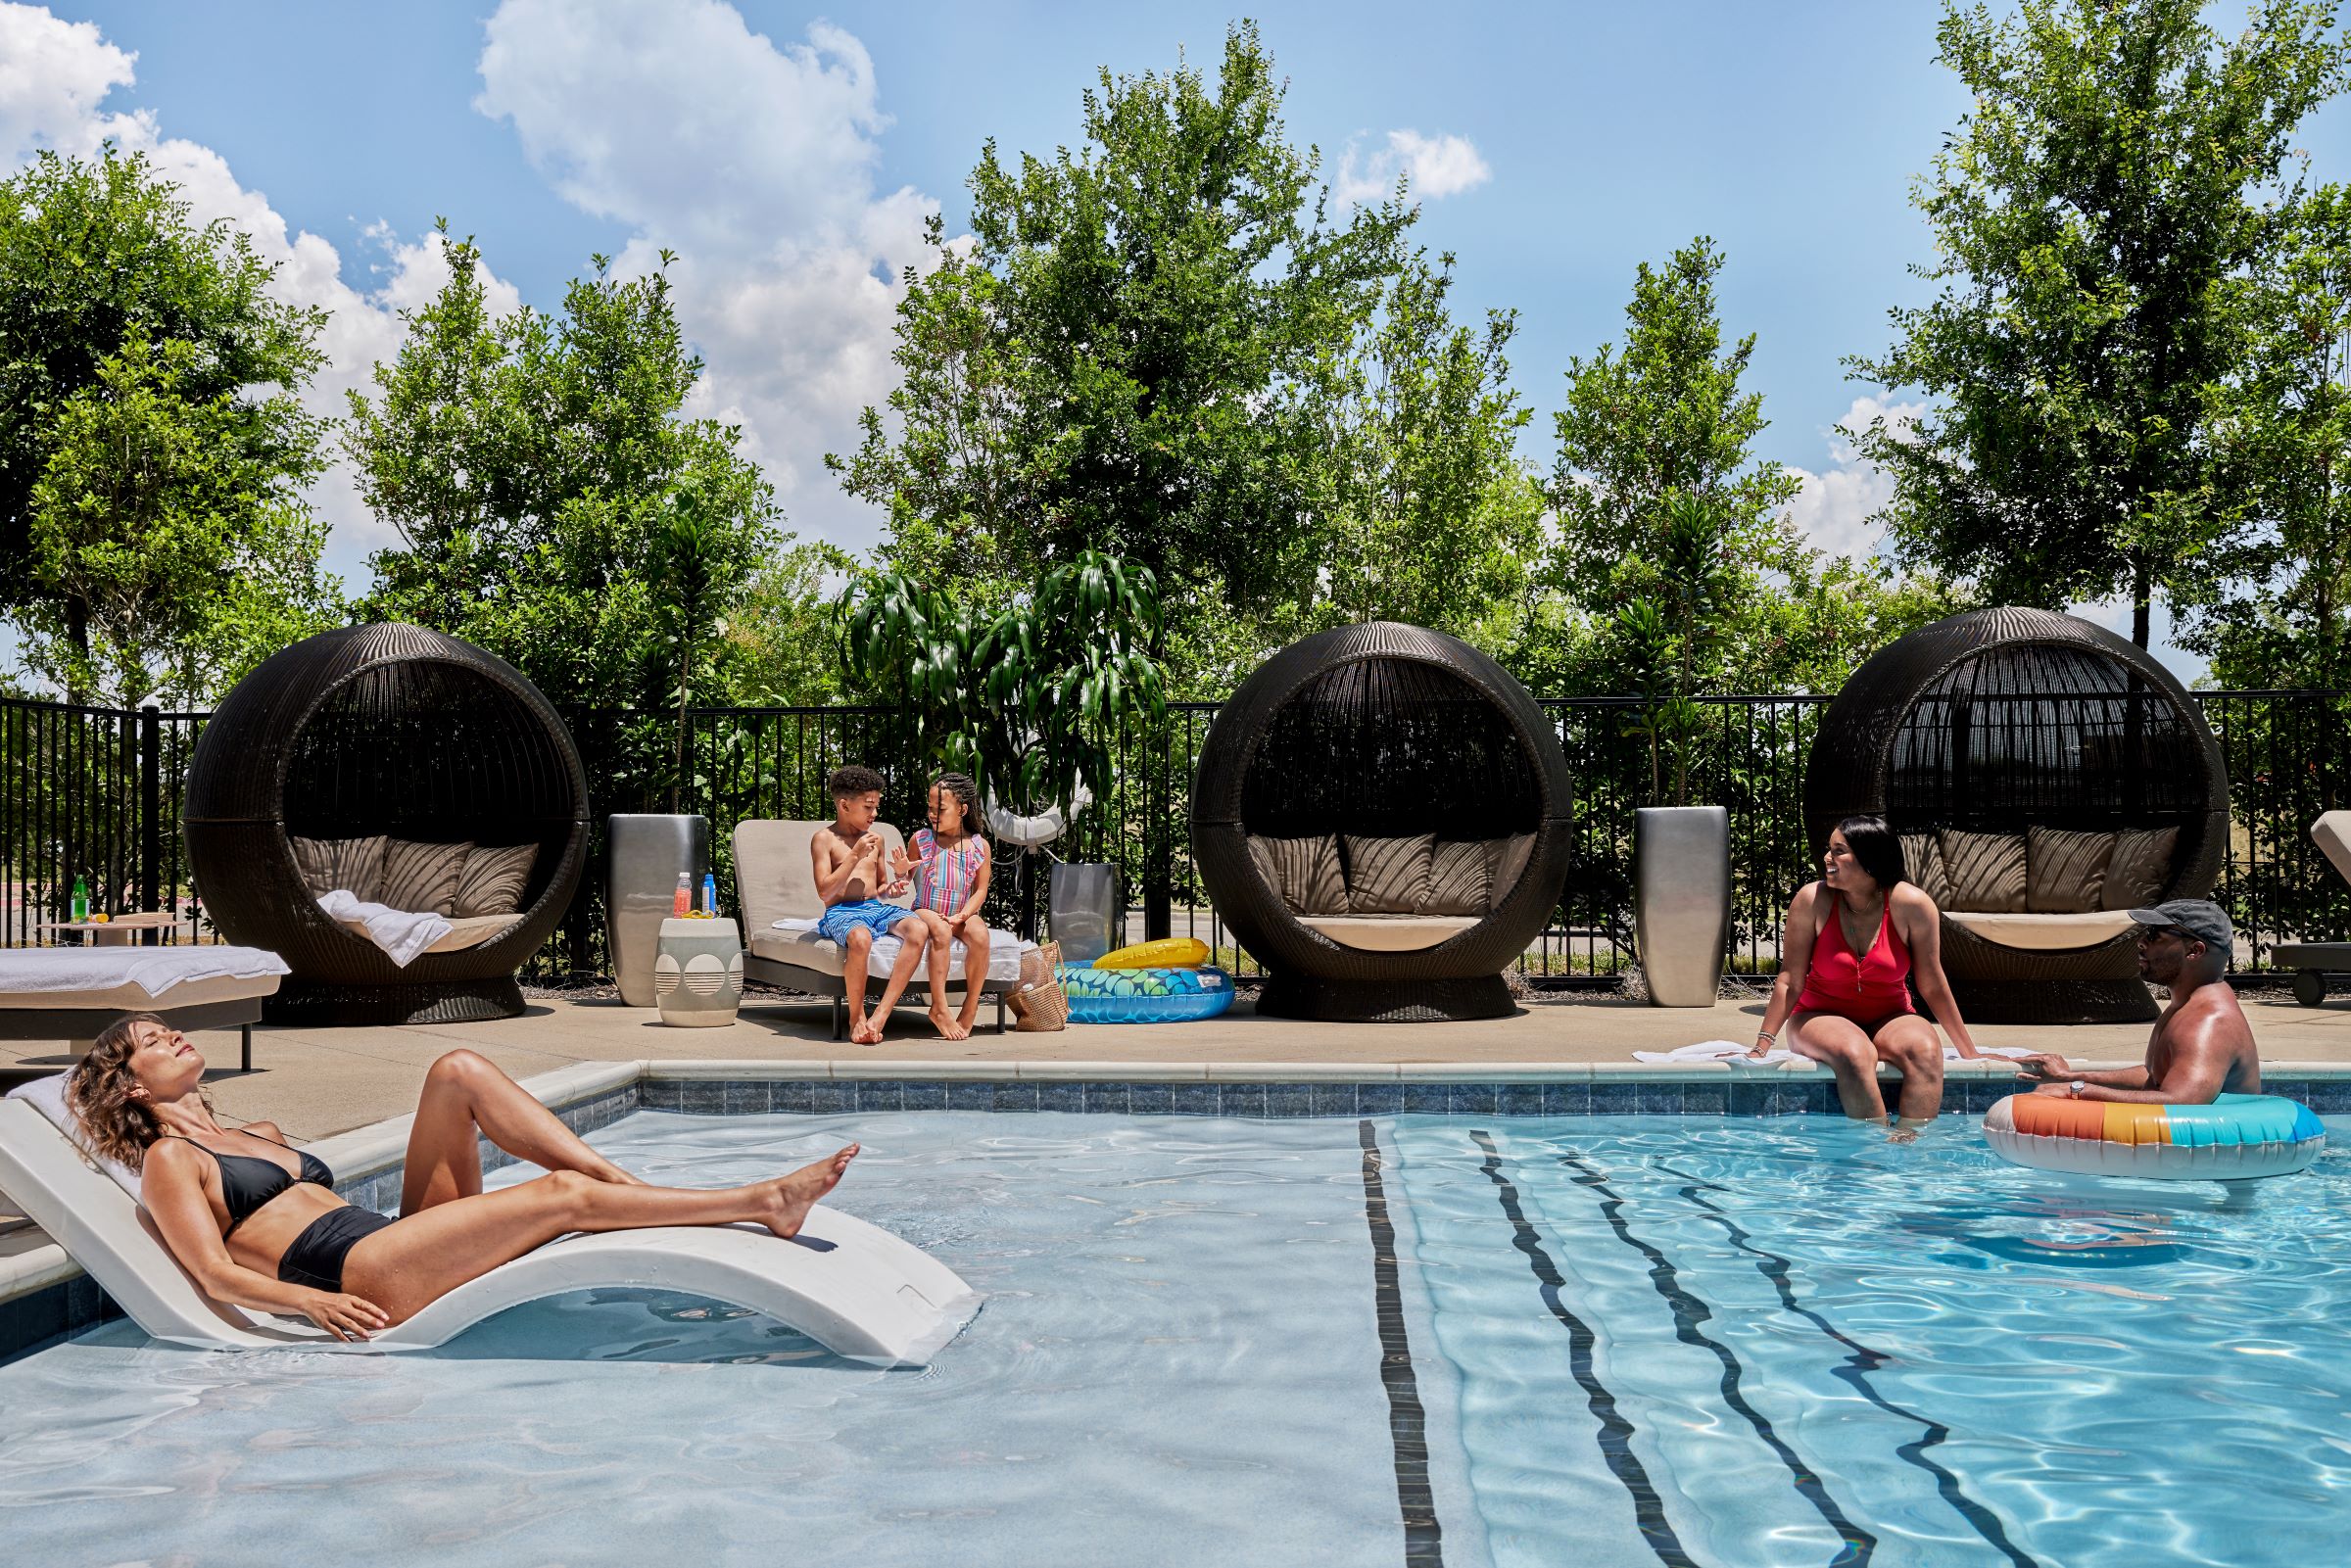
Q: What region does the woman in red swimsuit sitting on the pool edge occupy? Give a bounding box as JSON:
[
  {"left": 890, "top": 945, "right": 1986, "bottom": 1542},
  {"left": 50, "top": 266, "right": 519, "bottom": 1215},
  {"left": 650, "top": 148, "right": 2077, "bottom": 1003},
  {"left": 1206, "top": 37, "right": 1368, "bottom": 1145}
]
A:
[{"left": 1750, "top": 816, "right": 1977, "bottom": 1135}]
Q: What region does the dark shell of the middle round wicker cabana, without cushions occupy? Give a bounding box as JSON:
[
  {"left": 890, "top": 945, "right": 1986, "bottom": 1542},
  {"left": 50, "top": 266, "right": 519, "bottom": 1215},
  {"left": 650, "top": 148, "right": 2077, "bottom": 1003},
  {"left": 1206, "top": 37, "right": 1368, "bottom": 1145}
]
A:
[{"left": 1192, "top": 621, "right": 1573, "bottom": 1022}]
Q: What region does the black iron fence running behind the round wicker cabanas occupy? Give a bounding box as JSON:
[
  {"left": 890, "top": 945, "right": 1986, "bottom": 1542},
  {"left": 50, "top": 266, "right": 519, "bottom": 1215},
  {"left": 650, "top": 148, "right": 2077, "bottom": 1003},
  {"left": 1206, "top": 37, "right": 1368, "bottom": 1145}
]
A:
[{"left": 0, "top": 691, "right": 2351, "bottom": 982}]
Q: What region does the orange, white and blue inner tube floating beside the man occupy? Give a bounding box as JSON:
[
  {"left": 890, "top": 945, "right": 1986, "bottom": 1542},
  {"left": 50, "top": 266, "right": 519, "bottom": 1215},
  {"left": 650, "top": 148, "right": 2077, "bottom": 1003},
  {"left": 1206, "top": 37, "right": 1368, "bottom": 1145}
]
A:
[{"left": 1985, "top": 1093, "right": 2327, "bottom": 1182}]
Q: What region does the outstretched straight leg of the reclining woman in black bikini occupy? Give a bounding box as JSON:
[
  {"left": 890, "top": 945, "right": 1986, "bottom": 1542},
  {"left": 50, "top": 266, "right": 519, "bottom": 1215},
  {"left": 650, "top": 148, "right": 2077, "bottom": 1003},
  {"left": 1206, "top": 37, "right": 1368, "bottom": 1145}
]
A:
[{"left": 343, "top": 1143, "right": 858, "bottom": 1323}]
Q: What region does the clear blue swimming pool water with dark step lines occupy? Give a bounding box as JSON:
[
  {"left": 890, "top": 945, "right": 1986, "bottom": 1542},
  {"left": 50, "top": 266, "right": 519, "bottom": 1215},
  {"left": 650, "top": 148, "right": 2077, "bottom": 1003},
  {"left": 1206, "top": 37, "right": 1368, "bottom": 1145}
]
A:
[{"left": 0, "top": 1112, "right": 2351, "bottom": 1568}]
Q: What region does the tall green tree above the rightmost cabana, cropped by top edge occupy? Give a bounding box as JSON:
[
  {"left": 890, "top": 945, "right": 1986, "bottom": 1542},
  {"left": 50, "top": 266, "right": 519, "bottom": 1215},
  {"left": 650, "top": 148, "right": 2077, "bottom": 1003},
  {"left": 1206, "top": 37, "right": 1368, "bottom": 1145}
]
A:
[{"left": 1847, "top": 0, "right": 2346, "bottom": 646}]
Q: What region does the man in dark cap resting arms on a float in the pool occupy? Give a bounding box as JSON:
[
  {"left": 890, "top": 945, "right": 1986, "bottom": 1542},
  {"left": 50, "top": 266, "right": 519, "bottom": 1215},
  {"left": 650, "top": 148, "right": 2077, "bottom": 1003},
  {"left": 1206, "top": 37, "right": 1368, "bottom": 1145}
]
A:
[{"left": 2017, "top": 898, "right": 2262, "bottom": 1105}]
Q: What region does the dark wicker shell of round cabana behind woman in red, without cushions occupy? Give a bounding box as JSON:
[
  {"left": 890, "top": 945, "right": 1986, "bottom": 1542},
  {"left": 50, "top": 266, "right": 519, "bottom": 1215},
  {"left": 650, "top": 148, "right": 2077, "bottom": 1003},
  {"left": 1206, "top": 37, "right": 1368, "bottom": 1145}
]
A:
[{"left": 1803, "top": 609, "right": 2229, "bottom": 1022}]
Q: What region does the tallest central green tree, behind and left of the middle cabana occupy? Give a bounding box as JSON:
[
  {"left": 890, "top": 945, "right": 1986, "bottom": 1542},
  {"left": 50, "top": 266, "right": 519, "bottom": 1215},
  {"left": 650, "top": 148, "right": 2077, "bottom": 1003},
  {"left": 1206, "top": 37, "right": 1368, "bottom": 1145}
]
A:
[{"left": 828, "top": 24, "right": 1413, "bottom": 677}]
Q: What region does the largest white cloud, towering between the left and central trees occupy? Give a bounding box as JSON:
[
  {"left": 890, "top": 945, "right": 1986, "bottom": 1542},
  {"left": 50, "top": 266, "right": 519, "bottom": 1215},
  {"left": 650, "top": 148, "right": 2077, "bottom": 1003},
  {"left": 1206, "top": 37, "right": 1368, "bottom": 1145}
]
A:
[{"left": 475, "top": 0, "right": 938, "bottom": 547}]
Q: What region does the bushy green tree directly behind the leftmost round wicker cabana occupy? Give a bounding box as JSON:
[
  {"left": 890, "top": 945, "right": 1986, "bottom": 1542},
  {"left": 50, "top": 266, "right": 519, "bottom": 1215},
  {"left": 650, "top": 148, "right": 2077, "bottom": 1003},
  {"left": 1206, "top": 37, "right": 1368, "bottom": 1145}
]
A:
[{"left": 343, "top": 233, "right": 778, "bottom": 710}]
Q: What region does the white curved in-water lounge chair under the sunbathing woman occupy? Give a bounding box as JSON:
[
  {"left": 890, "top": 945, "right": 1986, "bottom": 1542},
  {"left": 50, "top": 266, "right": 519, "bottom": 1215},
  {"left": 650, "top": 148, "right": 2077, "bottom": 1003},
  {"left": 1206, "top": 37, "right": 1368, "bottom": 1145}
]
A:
[{"left": 0, "top": 1076, "right": 981, "bottom": 1366}]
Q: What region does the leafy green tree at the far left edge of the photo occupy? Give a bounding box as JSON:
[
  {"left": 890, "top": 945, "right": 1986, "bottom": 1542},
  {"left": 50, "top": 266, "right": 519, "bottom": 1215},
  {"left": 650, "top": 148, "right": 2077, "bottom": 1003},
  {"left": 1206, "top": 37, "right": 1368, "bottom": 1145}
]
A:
[{"left": 0, "top": 146, "right": 334, "bottom": 703}]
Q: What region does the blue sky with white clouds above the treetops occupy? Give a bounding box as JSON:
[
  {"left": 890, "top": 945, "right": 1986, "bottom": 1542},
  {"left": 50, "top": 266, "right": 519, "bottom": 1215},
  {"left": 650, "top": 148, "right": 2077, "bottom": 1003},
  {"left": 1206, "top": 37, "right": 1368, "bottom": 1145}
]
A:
[{"left": 14, "top": 0, "right": 2351, "bottom": 677}]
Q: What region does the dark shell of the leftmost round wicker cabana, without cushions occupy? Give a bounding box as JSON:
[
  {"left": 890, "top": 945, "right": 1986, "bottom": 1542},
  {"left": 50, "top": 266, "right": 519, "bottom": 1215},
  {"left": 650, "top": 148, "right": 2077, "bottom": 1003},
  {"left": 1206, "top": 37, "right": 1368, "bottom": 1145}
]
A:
[{"left": 183, "top": 625, "right": 588, "bottom": 1022}]
